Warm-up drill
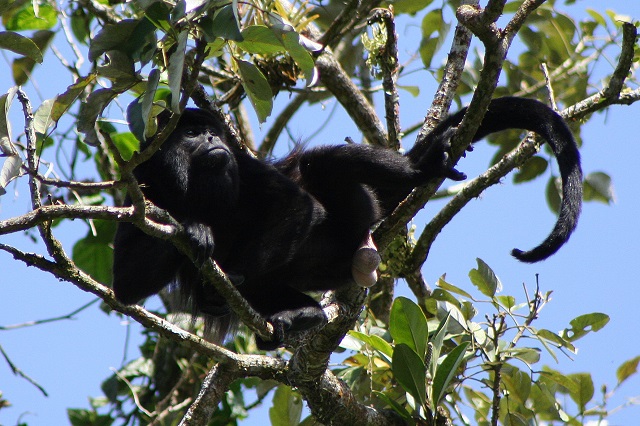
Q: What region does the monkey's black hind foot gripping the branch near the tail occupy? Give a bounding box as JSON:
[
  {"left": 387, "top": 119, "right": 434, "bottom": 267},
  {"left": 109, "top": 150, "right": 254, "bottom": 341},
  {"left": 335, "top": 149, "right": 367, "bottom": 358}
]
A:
[{"left": 417, "top": 128, "right": 467, "bottom": 180}]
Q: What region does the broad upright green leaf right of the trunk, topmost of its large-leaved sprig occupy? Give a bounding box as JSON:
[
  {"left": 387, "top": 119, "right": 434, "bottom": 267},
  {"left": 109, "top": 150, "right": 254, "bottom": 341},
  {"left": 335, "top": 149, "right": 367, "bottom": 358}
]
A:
[{"left": 389, "top": 297, "right": 429, "bottom": 358}]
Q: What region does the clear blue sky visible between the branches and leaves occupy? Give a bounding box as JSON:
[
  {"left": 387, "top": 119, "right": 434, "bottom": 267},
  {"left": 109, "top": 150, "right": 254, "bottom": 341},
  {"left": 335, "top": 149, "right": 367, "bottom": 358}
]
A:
[{"left": 0, "top": 0, "right": 640, "bottom": 425}]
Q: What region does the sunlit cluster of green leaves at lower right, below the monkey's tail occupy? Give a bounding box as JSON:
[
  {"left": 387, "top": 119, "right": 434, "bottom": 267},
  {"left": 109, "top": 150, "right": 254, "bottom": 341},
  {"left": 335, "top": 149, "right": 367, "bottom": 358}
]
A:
[{"left": 340, "top": 259, "right": 638, "bottom": 425}]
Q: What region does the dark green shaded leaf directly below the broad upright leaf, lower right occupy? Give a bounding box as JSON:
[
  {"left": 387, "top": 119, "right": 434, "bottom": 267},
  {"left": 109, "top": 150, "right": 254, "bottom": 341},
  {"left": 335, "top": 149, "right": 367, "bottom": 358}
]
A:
[{"left": 391, "top": 343, "right": 427, "bottom": 406}]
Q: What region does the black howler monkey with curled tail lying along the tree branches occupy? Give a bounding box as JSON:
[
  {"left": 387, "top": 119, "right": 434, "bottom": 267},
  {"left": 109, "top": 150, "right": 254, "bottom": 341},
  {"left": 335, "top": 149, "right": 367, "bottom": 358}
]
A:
[{"left": 113, "top": 97, "right": 582, "bottom": 349}]
